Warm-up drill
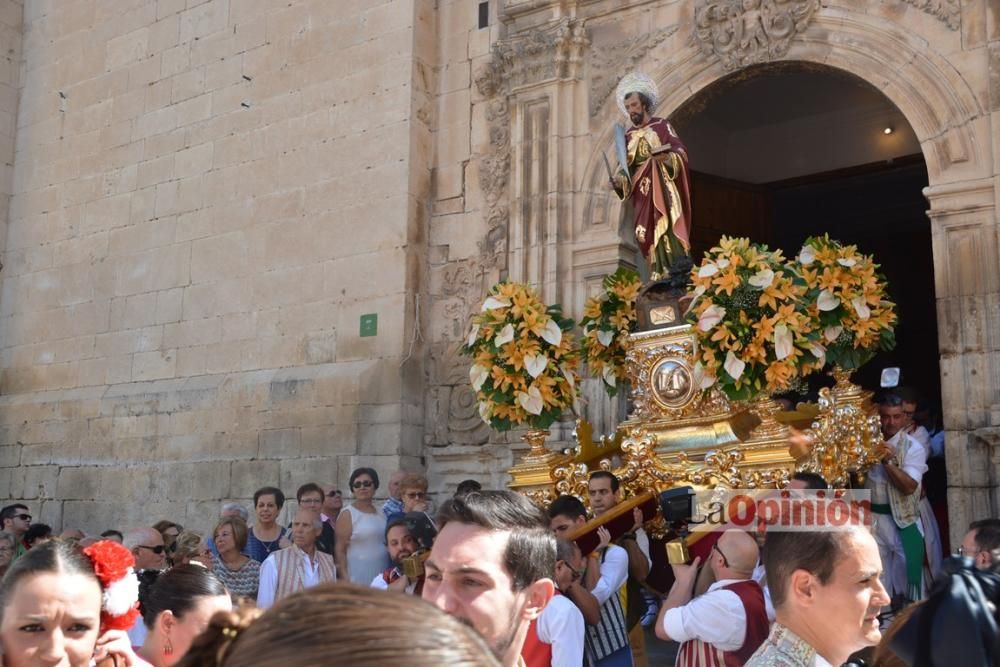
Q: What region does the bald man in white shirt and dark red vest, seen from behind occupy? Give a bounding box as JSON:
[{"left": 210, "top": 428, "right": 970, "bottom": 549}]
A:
[{"left": 656, "top": 530, "right": 769, "bottom": 667}]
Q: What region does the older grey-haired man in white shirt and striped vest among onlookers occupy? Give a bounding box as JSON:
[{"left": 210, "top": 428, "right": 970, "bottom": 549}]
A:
[{"left": 257, "top": 508, "right": 337, "bottom": 609}]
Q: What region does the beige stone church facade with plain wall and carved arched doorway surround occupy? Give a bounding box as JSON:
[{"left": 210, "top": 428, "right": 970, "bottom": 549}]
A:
[{"left": 0, "top": 0, "right": 1000, "bottom": 548}]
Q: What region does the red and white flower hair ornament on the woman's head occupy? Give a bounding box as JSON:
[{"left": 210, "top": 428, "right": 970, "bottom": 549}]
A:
[{"left": 83, "top": 540, "right": 139, "bottom": 632}]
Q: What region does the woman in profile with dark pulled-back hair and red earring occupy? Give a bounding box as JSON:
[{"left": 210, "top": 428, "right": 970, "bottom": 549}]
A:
[{"left": 139, "top": 563, "right": 233, "bottom": 667}]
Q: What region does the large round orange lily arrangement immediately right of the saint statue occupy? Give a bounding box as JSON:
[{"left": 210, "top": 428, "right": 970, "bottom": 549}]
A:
[{"left": 688, "top": 236, "right": 825, "bottom": 400}]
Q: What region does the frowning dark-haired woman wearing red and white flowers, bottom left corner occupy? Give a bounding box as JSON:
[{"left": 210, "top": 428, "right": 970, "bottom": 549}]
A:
[{"left": 0, "top": 540, "right": 139, "bottom": 667}]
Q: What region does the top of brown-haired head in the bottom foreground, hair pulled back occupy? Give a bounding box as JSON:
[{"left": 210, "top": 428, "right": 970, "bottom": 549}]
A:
[{"left": 177, "top": 584, "right": 500, "bottom": 667}]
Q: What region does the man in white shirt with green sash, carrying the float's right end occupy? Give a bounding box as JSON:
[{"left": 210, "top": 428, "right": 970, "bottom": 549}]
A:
[{"left": 865, "top": 394, "right": 927, "bottom": 600}]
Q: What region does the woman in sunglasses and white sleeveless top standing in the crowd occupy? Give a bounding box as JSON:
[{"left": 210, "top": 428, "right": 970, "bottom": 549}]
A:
[{"left": 334, "top": 468, "right": 389, "bottom": 586}]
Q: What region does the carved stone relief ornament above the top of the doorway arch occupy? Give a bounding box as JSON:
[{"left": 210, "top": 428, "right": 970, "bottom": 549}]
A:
[{"left": 695, "top": 0, "right": 819, "bottom": 70}]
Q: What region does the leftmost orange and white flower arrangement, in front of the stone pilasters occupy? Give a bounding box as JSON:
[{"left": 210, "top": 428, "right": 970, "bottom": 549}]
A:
[{"left": 462, "top": 282, "right": 580, "bottom": 431}]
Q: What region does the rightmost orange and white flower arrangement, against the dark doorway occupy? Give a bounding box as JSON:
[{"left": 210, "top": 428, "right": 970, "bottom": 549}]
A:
[{"left": 795, "top": 234, "right": 897, "bottom": 370}]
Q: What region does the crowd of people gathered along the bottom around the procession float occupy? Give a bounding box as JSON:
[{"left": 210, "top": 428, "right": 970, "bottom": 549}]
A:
[{"left": 0, "top": 394, "right": 1000, "bottom": 667}]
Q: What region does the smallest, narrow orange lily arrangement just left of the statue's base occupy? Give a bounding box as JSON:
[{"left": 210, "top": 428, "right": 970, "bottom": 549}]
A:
[{"left": 580, "top": 268, "right": 642, "bottom": 396}]
